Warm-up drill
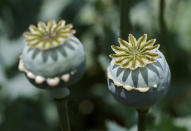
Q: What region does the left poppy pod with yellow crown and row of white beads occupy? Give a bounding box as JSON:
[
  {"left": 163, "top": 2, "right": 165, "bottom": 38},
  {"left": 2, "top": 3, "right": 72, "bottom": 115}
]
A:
[{"left": 19, "top": 20, "right": 86, "bottom": 88}]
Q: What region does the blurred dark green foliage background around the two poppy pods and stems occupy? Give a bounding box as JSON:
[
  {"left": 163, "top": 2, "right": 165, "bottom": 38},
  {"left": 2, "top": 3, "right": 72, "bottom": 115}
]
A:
[{"left": 0, "top": 0, "right": 191, "bottom": 131}]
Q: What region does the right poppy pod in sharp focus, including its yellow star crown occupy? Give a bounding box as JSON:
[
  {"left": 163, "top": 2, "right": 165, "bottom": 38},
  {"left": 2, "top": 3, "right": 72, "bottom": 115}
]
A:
[{"left": 107, "top": 34, "right": 171, "bottom": 108}]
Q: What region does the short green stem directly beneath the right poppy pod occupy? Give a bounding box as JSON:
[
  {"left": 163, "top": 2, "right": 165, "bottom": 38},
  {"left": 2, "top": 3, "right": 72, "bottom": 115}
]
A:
[{"left": 136, "top": 109, "right": 149, "bottom": 131}]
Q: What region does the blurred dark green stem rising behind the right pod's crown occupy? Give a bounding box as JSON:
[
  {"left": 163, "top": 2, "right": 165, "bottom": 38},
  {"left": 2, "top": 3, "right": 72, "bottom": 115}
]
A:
[{"left": 120, "top": 0, "right": 131, "bottom": 40}]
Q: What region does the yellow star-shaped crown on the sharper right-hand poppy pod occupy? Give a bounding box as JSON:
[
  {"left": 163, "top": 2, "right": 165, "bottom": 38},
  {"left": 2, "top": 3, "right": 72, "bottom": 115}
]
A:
[{"left": 109, "top": 34, "right": 160, "bottom": 70}]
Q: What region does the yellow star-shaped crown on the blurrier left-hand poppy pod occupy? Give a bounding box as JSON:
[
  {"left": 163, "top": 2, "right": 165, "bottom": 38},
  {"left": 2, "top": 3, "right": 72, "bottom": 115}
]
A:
[{"left": 24, "top": 20, "right": 76, "bottom": 50}]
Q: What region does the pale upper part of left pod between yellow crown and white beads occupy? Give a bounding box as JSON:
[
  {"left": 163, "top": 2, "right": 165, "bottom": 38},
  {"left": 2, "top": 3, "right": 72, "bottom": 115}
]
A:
[{"left": 22, "top": 37, "right": 85, "bottom": 78}]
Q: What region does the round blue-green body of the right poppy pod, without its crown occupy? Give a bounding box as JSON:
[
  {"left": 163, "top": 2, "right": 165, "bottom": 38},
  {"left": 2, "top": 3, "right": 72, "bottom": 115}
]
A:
[{"left": 107, "top": 33, "right": 171, "bottom": 108}]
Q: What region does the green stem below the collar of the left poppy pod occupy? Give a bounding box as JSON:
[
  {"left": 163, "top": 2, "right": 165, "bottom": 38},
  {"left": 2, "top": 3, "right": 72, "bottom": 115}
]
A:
[{"left": 55, "top": 98, "right": 70, "bottom": 131}]
